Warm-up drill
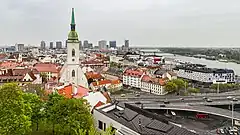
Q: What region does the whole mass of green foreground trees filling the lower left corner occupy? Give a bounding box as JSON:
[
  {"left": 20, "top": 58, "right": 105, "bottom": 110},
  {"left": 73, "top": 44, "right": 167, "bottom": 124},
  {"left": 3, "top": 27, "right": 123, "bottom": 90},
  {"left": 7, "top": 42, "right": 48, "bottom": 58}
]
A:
[{"left": 0, "top": 83, "right": 114, "bottom": 135}]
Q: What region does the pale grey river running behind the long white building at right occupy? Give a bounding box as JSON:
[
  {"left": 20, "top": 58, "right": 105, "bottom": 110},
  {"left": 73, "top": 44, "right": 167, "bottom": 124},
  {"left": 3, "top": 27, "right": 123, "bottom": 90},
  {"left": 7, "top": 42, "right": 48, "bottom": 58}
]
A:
[{"left": 146, "top": 52, "right": 240, "bottom": 75}]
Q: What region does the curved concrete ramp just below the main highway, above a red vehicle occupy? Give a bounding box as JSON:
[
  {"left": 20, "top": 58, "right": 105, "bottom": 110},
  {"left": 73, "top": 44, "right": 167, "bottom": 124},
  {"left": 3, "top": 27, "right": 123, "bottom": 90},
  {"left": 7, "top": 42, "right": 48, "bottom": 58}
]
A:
[{"left": 137, "top": 104, "right": 240, "bottom": 121}]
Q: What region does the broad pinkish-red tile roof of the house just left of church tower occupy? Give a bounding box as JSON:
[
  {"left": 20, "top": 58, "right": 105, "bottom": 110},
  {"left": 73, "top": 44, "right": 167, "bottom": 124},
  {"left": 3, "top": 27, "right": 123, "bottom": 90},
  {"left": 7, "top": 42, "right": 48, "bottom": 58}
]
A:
[{"left": 34, "top": 63, "right": 60, "bottom": 73}]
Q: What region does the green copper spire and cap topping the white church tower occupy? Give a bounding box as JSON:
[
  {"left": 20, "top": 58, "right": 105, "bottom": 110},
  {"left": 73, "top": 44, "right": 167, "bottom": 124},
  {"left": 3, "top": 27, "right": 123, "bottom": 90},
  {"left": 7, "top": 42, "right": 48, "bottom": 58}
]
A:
[{"left": 68, "top": 8, "right": 78, "bottom": 42}]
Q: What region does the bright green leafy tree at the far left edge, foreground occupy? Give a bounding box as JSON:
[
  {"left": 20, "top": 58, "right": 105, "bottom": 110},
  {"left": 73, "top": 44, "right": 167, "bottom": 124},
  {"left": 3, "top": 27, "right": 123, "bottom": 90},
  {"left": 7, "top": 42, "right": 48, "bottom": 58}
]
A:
[{"left": 0, "top": 83, "right": 32, "bottom": 135}]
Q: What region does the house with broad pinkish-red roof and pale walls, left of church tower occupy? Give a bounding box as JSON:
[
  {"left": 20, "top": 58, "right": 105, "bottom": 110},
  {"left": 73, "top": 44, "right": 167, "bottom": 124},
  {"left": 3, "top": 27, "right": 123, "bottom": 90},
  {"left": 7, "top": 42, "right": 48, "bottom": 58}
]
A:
[{"left": 34, "top": 63, "right": 60, "bottom": 80}]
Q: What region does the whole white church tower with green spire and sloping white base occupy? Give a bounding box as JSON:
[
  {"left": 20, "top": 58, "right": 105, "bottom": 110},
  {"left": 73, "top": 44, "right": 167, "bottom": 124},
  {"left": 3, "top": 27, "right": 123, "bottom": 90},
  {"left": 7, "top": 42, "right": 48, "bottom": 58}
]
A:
[{"left": 60, "top": 9, "right": 88, "bottom": 88}]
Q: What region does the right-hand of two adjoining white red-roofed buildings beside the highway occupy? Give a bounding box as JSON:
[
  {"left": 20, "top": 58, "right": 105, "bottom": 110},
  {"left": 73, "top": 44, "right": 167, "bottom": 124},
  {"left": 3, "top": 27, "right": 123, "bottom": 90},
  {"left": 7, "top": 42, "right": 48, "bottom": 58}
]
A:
[{"left": 141, "top": 75, "right": 167, "bottom": 95}]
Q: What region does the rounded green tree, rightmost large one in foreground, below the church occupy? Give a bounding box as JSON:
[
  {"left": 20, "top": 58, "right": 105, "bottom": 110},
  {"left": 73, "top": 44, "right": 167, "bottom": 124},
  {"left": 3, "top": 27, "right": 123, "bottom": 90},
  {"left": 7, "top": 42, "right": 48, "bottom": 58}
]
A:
[{"left": 46, "top": 94, "right": 93, "bottom": 135}]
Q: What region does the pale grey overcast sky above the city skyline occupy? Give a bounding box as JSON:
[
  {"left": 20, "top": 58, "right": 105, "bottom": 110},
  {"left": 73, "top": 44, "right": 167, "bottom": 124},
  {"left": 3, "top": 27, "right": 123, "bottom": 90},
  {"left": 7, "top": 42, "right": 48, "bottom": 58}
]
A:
[{"left": 0, "top": 0, "right": 240, "bottom": 47}]
